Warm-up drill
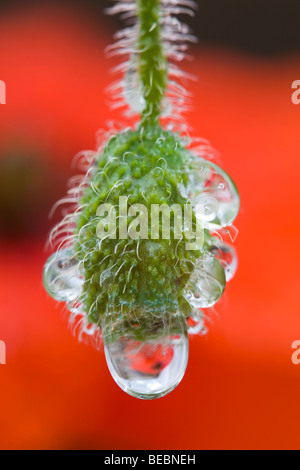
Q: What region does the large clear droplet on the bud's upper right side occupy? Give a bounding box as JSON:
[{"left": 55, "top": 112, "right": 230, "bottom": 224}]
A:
[{"left": 187, "top": 158, "right": 240, "bottom": 229}]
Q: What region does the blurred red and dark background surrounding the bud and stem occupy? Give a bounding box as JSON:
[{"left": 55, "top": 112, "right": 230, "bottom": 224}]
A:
[{"left": 0, "top": 0, "right": 300, "bottom": 449}]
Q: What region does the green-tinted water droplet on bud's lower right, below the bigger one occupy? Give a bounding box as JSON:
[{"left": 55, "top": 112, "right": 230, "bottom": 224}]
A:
[{"left": 184, "top": 255, "right": 226, "bottom": 308}]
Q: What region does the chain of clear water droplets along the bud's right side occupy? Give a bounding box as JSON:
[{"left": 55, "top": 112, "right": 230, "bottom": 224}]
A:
[{"left": 181, "top": 154, "right": 240, "bottom": 320}]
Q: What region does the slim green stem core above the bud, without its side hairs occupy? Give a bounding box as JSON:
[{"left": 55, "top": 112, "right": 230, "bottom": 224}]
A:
[{"left": 137, "top": 0, "right": 168, "bottom": 126}]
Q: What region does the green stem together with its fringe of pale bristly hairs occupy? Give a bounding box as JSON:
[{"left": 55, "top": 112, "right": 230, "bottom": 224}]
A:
[{"left": 108, "top": 0, "right": 197, "bottom": 127}]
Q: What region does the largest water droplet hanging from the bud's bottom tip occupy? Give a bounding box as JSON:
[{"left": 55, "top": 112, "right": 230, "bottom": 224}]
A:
[{"left": 102, "top": 311, "right": 188, "bottom": 400}]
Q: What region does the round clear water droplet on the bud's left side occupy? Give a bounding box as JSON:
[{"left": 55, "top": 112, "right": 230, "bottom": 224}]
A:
[{"left": 43, "top": 250, "right": 83, "bottom": 302}]
